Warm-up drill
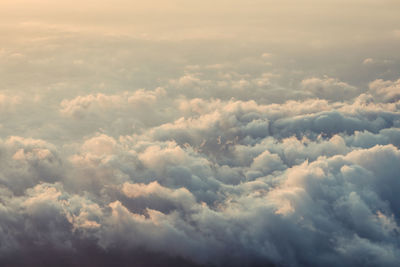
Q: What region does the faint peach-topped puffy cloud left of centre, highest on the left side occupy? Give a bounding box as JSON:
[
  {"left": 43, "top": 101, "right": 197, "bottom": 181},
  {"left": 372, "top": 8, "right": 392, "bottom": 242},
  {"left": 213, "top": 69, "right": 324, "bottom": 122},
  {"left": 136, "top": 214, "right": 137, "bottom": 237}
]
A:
[{"left": 55, "top": 87, "right": 178, "bottom": 141}]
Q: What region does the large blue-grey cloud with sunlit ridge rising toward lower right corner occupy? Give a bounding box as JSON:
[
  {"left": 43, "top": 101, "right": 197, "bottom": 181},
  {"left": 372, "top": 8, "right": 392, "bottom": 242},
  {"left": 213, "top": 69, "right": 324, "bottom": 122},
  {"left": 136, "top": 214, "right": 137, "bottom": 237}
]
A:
[{"left": 93, "top": 146, "right": 399, "bottom": 266}]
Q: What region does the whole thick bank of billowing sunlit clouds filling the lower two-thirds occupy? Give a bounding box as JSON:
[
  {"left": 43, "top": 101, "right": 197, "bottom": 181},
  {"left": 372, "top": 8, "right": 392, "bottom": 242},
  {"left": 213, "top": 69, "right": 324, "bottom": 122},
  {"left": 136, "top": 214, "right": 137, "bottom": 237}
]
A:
[{"left": 0, "top": 78, "right": 400, "bottom": 266}]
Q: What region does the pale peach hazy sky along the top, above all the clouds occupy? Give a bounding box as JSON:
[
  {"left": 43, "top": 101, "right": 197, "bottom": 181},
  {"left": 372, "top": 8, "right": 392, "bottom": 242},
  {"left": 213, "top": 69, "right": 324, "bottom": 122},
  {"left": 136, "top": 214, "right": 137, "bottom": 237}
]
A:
[{"left": 0, "top": 0, "right": 400, "bottom": 40}]
